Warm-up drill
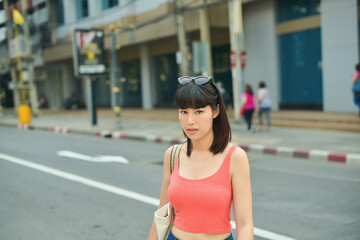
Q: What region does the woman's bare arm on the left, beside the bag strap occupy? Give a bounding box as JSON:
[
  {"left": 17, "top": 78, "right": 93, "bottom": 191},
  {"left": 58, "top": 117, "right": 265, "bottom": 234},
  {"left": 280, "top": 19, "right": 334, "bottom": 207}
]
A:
[{"left": 148, "top": 147, "right": 172, "bottom": 240}]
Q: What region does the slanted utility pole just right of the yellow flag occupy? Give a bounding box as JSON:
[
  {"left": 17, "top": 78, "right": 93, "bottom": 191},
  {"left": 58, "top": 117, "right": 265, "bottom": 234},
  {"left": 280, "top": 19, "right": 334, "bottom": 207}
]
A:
[{"left": 21, "top": 0, "right": 39, "bottom": 117}]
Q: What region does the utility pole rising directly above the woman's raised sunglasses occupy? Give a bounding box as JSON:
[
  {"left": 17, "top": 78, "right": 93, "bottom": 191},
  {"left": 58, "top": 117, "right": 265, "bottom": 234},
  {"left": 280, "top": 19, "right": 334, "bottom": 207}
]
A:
[{"left": 176, "top": 0, "right": 189, "bottom": 76}]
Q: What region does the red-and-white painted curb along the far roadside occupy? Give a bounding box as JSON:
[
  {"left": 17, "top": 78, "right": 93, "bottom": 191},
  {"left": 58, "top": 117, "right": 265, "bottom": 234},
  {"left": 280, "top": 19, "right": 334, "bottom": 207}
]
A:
[{"left": 0, "top": 122, "right": 360, "bottom": 165}]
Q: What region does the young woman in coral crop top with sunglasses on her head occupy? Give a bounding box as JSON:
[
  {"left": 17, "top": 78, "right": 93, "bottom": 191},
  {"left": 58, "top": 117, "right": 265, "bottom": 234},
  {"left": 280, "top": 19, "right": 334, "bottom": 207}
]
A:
[{"left": 148, "top": 76, "right": 254, "bottom": 240}]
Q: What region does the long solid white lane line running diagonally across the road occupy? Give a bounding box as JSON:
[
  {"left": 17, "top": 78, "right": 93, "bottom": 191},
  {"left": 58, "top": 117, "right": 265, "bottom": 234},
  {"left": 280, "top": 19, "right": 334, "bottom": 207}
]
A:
[{"left": 0, "top": 153, "right": 295, "bottom": 240}]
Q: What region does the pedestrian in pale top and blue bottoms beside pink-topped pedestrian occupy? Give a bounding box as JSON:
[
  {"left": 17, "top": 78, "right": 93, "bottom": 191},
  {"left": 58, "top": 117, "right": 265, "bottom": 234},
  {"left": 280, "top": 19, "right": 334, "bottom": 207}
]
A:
[{"left": 258, "top": 82, "right": 271, "bottom": 131}]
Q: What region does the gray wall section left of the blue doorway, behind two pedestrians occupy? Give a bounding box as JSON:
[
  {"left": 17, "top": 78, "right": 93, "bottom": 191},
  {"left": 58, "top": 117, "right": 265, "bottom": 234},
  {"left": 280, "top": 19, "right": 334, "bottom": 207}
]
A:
[{"left": 243, "top": 0, "right": 280, "bottom": 110}]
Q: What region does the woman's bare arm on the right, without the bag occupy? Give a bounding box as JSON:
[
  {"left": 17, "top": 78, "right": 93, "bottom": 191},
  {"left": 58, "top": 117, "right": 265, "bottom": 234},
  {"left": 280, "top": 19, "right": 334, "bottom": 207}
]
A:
[{"left": 230, "top": 148, "right": 254, "bottom": 240}]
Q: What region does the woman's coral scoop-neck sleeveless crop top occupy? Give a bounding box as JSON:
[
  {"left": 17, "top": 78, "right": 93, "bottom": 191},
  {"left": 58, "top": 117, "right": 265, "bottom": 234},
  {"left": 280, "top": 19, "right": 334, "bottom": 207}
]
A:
[{"left": 168, "top": 146, "right": 236, "bottom": 234}]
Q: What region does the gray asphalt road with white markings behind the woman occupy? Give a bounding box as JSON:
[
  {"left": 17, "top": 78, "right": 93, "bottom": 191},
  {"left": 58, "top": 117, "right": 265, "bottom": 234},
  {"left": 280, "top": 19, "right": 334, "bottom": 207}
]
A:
[{"left": 0, "top": 127, "right": 360, "bottom": 240}]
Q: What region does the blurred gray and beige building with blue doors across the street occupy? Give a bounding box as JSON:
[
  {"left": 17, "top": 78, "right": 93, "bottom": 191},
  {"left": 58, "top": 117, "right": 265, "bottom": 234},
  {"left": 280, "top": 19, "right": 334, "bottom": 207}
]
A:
[{"left": 0, "top": 0, "right": 359, "bottom": 112}]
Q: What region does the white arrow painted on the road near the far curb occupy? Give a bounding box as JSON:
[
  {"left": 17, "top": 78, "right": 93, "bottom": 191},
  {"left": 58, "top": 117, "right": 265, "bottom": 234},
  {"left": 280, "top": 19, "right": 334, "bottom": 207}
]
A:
[{"left": 57, "top": 151, "right": 129, "bottom": 164}]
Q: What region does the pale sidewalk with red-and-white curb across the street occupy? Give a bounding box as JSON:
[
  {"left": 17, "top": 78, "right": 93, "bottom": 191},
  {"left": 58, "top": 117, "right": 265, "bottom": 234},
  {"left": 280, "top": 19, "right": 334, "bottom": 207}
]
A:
[{"left": 0, "top": 109, "right": 360, "bottom": 164}]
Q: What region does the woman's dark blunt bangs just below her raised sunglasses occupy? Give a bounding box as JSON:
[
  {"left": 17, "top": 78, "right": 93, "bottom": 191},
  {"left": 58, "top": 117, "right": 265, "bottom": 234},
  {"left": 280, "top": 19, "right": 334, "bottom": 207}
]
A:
[{"left": 175, "top": 82, "right": 218, "bottom": 109}]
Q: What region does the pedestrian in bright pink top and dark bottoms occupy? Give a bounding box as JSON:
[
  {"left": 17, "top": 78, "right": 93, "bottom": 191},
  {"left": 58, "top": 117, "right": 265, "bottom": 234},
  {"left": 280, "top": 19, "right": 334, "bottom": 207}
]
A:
[{"left": 240, "top": 84, "right": 256, "bottom": 133}]
